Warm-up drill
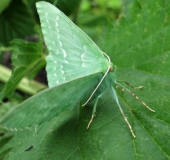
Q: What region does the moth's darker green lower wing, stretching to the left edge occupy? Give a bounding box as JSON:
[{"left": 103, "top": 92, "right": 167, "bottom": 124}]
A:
[{"left": 0, "top": 74, "right": 102, "bottom": 130}]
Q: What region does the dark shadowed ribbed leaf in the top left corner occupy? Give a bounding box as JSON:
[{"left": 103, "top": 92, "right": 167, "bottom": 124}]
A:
[{"left": 0, "top": 0, "right": 34, "bottom": 46}]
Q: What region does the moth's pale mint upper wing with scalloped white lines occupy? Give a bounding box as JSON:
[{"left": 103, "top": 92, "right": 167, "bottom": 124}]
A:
[{"left": 37, "top": 2, "right": 110, "bottom": 86}]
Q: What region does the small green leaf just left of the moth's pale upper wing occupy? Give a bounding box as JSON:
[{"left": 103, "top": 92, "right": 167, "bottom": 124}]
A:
[{"left": 0, "top": 40, "right": 44, "bottom": 100}]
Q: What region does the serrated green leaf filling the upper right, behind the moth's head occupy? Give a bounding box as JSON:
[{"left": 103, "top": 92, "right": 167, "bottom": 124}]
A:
[{"left": 99, "top": 0, "right": 170, "bottom": 76}]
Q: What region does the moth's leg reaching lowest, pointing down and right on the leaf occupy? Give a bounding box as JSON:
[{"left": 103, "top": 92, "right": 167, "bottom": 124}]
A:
[{"left": 112, "top": 87, "right": 136, "bottom": 138}]
